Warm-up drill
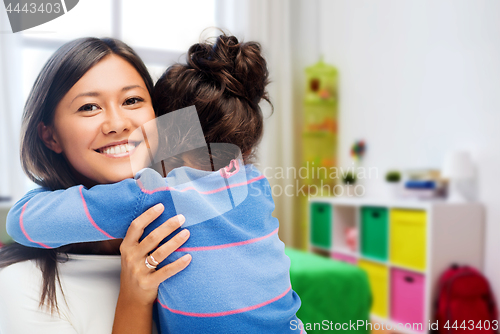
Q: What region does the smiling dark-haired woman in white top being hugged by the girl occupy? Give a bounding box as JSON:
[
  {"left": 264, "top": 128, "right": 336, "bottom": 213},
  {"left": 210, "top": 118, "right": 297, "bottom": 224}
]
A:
[{"left": 0, "top": 38, "right": 189, "bottom": 334}]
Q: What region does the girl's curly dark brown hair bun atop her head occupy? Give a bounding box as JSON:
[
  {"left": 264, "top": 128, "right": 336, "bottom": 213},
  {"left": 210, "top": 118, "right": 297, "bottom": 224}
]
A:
[{"left": 187, "top": 35, "right": 269, "bottom": 104}]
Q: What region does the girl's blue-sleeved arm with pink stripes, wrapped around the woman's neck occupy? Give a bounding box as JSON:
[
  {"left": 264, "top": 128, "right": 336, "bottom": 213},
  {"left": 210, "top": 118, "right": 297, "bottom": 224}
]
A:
[{"left": 7, "top": 179, "right": 144, "bottom": 248}]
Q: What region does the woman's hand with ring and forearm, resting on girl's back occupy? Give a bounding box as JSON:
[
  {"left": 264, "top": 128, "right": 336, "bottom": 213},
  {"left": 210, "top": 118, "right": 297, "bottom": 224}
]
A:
[{"left": 113, "top": 204, "right": 191, "bottom": 334}]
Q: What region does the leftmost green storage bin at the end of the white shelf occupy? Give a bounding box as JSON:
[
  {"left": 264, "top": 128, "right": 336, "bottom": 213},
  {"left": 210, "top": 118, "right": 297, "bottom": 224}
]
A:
[{"left": 311, "top": 203, "right": 332, "bottom": 249}]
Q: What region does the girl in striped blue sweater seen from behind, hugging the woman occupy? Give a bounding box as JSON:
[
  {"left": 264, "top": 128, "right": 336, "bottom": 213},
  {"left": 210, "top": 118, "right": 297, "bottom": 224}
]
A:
[{"left": 8, "top": 36, "right": 300, "bottom": 333}]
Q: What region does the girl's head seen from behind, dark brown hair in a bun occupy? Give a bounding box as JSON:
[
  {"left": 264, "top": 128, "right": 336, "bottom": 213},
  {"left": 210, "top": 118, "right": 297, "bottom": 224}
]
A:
[{"left": 153, "top": 35, "right": 270, "bottom": 170}]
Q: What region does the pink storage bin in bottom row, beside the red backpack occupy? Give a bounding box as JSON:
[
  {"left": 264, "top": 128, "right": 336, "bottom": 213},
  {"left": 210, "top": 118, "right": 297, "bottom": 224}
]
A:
[{"left": 390, "top": 268, "right": 426, "bottom": 330}]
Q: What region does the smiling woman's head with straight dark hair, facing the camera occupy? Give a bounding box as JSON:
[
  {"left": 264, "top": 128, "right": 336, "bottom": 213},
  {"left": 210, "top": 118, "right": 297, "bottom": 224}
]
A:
[{"left": 21, "top": 38, "right": 155, "bottom": 189}]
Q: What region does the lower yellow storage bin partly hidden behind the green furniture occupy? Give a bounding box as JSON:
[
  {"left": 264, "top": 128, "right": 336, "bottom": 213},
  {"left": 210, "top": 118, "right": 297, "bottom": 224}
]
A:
[{"left": 358, "top": 260, "right": 389, "bottom": 318}]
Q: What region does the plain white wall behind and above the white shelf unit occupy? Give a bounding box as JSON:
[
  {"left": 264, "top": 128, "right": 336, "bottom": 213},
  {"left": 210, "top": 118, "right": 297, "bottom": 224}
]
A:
[{"left": 292, "top": 0, "right": 500, "bottom": 298}]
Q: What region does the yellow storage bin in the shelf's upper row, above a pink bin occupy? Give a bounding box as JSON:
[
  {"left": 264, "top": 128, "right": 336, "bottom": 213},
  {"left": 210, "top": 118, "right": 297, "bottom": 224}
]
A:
[{"left": 390, "top": 209, "right": 427, "bottom": 270}]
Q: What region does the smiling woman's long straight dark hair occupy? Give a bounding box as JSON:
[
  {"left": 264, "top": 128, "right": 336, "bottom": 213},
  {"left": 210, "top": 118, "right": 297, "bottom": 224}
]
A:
[{"left": 0, "top": 38, "right": 153, "bottom": 311}]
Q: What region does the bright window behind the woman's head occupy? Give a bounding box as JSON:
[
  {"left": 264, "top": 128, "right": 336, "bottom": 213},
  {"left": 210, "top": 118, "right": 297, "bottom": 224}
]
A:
[{"left": 13, "top": 0, "right": 216, "bottom": 193}]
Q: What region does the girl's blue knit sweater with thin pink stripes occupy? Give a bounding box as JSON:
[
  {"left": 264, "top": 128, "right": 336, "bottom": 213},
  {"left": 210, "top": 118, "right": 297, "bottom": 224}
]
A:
[{"left": 7, "top": 162, "right": 300, "bottom": 334}]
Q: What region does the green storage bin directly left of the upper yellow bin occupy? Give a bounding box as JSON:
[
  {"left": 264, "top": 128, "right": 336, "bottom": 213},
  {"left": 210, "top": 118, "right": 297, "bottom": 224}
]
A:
[{"left": 361, "top": 207, "right": 389, "bottom": 261}]
